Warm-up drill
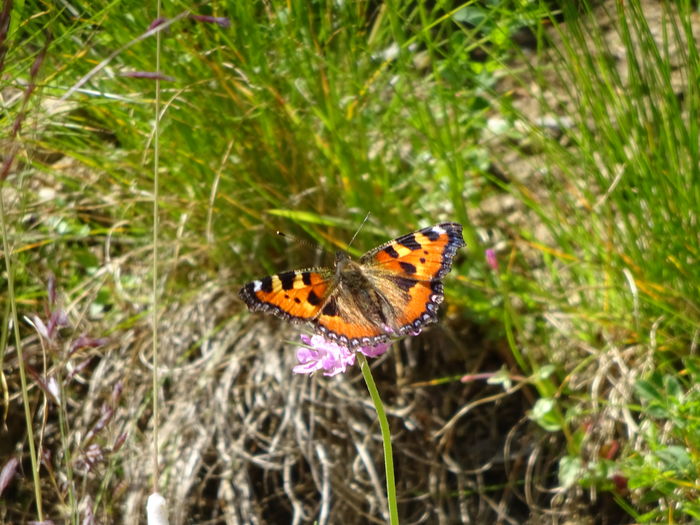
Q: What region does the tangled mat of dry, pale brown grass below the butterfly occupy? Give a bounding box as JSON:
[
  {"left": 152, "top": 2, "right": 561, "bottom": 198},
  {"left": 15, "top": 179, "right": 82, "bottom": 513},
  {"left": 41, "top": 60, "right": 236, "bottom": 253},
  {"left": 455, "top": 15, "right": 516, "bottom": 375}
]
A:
[{"left": 106, "top": 287, "right": 530, "bottom": 523}]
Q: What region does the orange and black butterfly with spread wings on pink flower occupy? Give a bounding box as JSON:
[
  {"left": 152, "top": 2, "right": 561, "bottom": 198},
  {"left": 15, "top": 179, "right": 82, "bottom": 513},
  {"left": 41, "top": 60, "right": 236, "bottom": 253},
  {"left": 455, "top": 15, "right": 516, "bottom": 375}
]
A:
[{"left": 239, "top": 222, "right": 465, "bottom": 348}]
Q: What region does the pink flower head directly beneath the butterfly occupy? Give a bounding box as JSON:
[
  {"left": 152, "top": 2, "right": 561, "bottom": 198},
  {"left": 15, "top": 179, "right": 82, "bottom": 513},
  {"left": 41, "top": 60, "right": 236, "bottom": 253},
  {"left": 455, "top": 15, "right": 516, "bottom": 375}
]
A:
[{"left": 293, "top": 334, "right": 391, "bottom": 376}]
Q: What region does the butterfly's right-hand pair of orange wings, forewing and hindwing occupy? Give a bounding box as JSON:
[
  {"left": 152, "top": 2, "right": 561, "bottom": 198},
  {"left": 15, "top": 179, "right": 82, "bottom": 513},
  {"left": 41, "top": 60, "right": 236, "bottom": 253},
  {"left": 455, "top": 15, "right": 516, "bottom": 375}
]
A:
[{"left": 360, "top": 222, "right": 465, "bottom": 334}]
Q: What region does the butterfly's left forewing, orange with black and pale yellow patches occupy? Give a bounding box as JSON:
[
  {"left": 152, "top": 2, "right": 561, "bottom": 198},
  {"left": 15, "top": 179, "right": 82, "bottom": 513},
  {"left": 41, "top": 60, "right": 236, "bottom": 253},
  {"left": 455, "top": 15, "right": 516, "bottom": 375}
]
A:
[{"left": 238, "top": 268, "right": 334, "bottom": 323}]
